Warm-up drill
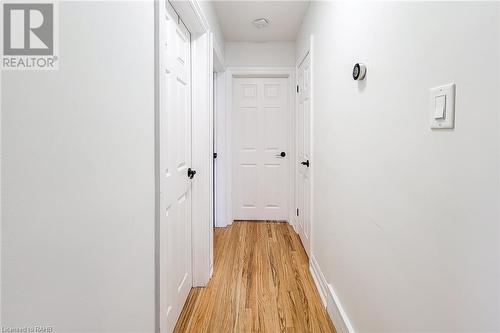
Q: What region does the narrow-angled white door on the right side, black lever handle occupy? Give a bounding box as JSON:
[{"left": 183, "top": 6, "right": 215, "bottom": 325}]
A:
[{"left": 296, "top": 54, "right": 311, "bottom": 255}]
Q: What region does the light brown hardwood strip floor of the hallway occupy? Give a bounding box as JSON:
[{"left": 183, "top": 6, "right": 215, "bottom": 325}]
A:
[{"left": 175, "top": 222, "right": 335, "bottom": 333}]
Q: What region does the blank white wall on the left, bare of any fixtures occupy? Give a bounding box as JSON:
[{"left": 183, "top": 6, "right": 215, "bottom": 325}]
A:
[{"left": 1, "top": 1, "right": 155, "bottom": 332}]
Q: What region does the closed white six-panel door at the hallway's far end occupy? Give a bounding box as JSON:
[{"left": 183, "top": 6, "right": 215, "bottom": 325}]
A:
[{"left": 232, "top": 78, "right": 290, "bottom": 220}]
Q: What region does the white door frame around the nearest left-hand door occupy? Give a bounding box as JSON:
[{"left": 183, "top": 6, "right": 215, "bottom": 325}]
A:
[{"left": 154, "top": 0, "right": 218, "bottom": 332}]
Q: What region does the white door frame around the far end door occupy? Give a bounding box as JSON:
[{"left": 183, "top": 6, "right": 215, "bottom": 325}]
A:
[{"left": 225, "top": 67, "right": 296, "bottom": 225}]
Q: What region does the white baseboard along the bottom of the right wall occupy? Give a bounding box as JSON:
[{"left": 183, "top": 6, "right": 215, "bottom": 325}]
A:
[{"left": 309, "top": 255, "right": 355, "bottom": 333}]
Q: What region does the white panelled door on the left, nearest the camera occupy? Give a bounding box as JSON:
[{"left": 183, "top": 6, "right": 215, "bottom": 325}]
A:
[{"left": 159, "top": 1, "right": 192, "bottom": 332}]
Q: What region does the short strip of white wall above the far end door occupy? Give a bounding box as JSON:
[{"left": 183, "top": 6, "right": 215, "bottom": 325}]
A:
[{"left": 226, "top": 42, "right": 295, "bottom": 67}]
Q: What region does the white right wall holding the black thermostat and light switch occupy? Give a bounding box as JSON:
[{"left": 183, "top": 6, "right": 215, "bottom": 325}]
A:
[{"left": 297, "top": 2, "right": 500, "bottom": 332}]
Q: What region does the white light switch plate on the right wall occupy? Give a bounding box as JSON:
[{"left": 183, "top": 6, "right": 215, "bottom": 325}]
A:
[{"left": 429, "top": 83, "right": 456, "bottom": 129}]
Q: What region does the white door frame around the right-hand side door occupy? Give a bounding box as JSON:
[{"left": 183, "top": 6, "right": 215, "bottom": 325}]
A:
[{"left": 294, "top": 35, "right": 315, "bottom": 254}]
